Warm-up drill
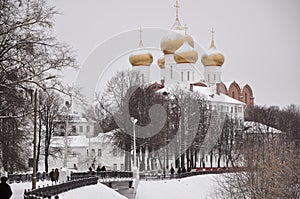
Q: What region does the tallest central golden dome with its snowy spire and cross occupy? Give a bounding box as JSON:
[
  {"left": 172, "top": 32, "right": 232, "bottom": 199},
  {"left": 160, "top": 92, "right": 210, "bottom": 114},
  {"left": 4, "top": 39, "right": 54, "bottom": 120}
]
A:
[{"left": 160, "top": 0, "right": 194, "bottom": 55}]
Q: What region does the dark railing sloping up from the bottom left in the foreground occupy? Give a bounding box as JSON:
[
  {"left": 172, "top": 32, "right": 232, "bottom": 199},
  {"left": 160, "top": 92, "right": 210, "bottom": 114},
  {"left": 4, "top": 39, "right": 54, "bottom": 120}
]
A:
[{"left": 24, "top": 177, "right": 98, "bottom": 199}]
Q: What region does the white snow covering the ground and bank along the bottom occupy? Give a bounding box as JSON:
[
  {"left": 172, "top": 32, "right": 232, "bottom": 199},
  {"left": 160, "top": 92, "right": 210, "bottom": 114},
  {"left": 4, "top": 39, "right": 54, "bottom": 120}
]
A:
[{"left": 10, "top": 175, "right": 218, "bottom": 199}]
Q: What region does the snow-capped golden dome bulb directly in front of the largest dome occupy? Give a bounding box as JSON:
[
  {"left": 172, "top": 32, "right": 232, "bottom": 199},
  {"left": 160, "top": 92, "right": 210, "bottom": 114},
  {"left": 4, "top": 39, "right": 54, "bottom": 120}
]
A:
[{"left": 174, "top": 41, "right": 198, "bottom": 64}]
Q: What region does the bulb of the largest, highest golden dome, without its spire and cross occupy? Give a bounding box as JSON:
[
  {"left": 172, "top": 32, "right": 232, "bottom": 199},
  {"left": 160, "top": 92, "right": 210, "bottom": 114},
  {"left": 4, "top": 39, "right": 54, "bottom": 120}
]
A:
[{"left": 160, "top": 31, "right": 194, "bottom": 55}]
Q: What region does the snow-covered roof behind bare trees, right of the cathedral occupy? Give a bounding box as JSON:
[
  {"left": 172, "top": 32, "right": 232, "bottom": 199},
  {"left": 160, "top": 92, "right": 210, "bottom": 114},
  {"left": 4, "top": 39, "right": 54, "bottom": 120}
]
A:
[{"left": 244, "top": 121, "right": 283, "bottom": 133}]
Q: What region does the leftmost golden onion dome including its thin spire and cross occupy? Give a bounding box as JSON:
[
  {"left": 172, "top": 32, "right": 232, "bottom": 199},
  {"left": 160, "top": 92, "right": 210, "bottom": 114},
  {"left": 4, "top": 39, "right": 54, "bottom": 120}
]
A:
[{"left": 129, "top": 28, "right": 153, "bottom": 66}]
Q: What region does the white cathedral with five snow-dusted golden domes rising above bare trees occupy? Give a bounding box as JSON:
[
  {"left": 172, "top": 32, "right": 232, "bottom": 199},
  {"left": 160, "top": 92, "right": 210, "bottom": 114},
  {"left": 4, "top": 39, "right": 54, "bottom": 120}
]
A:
[{"left": 129, "top": 0, "right": 254, "bottom": 123}]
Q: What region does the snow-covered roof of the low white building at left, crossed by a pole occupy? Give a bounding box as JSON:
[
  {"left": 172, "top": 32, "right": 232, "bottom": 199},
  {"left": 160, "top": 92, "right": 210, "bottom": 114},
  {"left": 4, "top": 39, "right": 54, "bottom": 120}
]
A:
[{"left": 51, "top": 135, "right": 88, "bottom": 148}]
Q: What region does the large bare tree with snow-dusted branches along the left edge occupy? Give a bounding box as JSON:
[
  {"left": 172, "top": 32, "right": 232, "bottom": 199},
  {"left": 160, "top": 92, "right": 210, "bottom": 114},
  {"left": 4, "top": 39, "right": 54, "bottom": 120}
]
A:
[{"left": 0, "top": 0, "right": 75, "bottom": 170}]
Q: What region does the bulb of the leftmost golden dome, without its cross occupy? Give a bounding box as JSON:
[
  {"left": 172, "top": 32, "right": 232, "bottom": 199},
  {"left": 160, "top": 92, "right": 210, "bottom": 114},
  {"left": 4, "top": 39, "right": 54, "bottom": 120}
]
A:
[{"left": 129, "top": 50, "right": 153, "bottom": 66}]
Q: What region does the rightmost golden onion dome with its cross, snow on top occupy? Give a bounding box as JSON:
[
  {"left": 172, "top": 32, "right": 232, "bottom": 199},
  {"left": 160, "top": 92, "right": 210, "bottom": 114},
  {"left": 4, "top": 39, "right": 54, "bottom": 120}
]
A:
[{"left": 201, "top": 29, "right": 225, "bottom": 66}]
